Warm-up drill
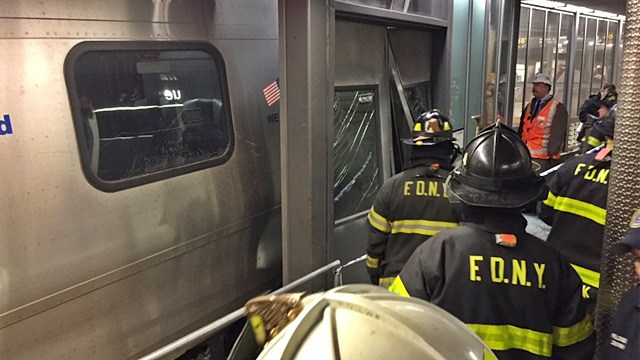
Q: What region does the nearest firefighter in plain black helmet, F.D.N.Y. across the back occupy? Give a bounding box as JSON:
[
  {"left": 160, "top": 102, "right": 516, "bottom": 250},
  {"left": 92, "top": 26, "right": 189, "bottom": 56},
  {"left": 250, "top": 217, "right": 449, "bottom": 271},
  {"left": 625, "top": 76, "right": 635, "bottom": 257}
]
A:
[{"left": 389, "top": 123, "right": 595, "bottom": 360}]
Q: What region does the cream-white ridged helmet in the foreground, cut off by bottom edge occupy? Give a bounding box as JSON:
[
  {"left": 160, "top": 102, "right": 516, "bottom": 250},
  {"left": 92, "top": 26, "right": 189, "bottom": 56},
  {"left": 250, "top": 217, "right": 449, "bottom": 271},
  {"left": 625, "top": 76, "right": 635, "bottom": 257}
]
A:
[{"left": 258, "top": 284, "right": 497, "bottom": 360}]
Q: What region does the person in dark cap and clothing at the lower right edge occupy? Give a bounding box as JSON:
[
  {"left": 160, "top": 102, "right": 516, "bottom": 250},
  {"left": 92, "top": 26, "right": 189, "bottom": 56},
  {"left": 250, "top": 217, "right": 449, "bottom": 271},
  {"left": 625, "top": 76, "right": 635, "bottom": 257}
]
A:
[{"left": 600, "top": 209, "right": 640, "bottom": 360}]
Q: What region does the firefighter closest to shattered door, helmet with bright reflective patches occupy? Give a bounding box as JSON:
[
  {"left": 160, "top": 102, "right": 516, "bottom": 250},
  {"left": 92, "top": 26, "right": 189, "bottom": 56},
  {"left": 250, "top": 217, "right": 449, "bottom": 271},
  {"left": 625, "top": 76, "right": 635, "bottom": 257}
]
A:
[{"left": 366, "top": 110, "right": 461, "bottom": 288}]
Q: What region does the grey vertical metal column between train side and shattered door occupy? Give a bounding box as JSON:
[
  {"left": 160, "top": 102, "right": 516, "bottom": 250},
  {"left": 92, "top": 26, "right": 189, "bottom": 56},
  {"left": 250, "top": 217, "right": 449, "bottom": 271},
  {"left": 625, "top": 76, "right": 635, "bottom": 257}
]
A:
[{"left": 278, "top": 0, "right": 335, "bottom": 290}]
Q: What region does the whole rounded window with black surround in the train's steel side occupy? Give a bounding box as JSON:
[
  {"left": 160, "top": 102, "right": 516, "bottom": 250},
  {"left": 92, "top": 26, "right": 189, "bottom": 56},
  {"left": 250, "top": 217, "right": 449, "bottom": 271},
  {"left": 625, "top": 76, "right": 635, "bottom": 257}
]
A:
[{"left": 65, "top": 42, "right": 233, "bottom": 191}]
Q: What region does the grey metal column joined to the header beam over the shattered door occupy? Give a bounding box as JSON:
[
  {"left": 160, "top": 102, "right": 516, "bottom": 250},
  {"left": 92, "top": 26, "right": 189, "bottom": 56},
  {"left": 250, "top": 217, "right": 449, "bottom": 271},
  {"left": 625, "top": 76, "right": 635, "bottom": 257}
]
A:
[{"left": 278, "top": 0, "right": 453, "bottom": 289}]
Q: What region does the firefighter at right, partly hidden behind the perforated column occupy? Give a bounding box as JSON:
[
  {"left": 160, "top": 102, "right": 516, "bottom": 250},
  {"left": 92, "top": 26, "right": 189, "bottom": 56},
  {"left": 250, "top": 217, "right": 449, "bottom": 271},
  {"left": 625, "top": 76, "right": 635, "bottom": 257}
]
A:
[{"left": 539, "top": 114, "right": 615, "bottom": 314}]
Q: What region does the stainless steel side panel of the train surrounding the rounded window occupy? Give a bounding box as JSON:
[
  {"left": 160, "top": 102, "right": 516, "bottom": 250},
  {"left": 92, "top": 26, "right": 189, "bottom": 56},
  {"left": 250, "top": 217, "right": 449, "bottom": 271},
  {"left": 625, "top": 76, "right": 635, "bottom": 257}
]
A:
[{"left": 0, "top": 0, "right": 281, "bottom": 359}]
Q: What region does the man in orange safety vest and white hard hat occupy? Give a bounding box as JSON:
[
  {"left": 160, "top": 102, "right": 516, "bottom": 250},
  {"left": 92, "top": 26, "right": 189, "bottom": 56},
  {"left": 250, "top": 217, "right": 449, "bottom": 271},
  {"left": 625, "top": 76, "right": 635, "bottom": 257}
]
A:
[{"left": 518, "top": 74, "right": 568, "bottom": 173}]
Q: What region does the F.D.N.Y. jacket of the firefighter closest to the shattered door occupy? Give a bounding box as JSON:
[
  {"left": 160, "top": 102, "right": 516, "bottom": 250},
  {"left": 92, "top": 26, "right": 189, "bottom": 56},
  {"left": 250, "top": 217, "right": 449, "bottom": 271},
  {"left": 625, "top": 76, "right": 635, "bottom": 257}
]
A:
[{"left": 366, "top": 160, "right": 461, "bottom": 287}]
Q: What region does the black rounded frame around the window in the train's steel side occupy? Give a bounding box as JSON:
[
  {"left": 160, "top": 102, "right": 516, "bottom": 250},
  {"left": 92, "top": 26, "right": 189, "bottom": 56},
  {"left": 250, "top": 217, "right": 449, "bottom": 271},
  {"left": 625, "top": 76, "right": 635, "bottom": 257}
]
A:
[{"left": 64, "top": 41, "right": 235, "bottom": 192}]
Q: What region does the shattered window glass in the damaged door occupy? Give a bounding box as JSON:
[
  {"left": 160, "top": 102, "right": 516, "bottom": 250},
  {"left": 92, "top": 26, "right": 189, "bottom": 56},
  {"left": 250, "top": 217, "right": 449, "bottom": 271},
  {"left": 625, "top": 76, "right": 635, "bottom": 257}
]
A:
[{"left": 333, "top": 89, "right": 379, "bottom": 220}]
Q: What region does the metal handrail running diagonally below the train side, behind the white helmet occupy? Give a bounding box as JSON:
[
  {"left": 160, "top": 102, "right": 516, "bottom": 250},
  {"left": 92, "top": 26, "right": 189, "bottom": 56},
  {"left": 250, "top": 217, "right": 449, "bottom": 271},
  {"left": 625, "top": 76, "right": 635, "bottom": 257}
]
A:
[{"left": 140, "top": 260, "right": 340, "bottom": 360}]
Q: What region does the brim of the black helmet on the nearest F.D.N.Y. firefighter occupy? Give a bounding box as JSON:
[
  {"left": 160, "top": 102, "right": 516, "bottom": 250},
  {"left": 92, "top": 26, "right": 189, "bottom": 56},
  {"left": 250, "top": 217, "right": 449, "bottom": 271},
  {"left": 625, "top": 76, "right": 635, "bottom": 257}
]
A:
[{"left": 447, "top": 171, "right": 547, "bottom": 208}]
